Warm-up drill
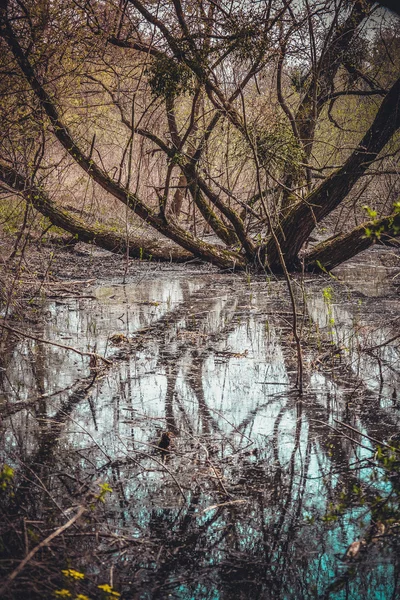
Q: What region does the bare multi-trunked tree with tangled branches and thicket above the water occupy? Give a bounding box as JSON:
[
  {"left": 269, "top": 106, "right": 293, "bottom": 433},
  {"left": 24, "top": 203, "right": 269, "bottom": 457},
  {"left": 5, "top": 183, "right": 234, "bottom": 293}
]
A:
[{"left": 0, "top": 0, "right": 400, "bottom": 272}]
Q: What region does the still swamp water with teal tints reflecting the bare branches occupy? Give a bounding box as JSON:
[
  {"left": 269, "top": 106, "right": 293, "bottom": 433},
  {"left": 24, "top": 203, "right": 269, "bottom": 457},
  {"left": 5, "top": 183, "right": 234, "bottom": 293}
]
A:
[{"left": 0, "top": 254, "right": 400, "bottom": 600}]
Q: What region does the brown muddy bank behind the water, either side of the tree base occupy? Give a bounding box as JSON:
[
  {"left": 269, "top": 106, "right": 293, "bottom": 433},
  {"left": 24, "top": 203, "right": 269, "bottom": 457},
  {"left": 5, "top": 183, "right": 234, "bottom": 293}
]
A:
[{"left": 3, "top": 237, "right": 400, "bottom": 297}]
